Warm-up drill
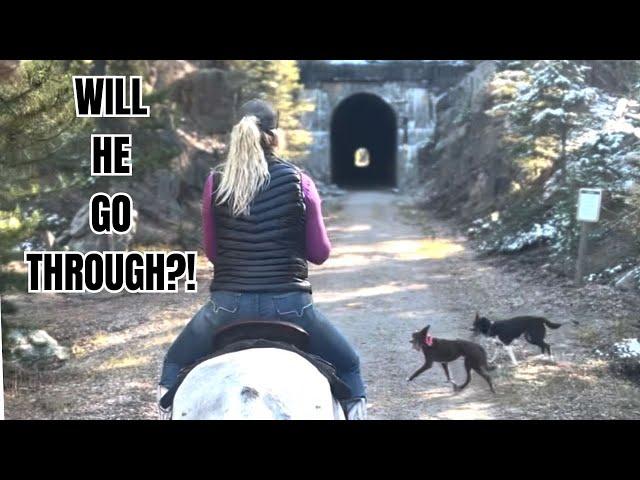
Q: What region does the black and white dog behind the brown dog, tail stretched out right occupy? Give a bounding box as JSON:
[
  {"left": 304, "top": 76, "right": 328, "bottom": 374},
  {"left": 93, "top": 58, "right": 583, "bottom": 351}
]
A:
[{"left": 471, "top": 312, "right": 578, "bottom": 365}]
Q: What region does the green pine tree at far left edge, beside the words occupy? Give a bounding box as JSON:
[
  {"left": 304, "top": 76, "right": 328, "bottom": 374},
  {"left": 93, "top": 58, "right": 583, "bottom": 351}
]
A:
[{"left": 0, "top": 61, "right": 90, "bottom": 292}]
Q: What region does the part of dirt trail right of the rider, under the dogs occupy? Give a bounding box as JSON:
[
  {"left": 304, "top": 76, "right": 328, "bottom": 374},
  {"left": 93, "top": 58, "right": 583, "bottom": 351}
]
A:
[{"left": 311, "top": 192, "right": 640, "bottom": 419}]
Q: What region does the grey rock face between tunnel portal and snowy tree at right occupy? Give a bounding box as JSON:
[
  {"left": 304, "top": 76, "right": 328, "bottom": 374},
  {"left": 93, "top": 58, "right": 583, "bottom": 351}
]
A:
[{"left": 418, "top": 61, "right": 509, "bottom": 219}]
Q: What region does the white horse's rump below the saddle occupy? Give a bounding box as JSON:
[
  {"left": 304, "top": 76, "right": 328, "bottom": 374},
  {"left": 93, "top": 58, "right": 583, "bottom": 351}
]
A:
[{"left": 172, "top": 348, "right": 345, "bottom": 420}]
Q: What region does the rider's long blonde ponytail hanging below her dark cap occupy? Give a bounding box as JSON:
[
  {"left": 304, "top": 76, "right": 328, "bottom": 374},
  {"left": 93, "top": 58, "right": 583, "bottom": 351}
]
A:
[{"left": 216, "top": 115, "right": 278, "bottom": 217}]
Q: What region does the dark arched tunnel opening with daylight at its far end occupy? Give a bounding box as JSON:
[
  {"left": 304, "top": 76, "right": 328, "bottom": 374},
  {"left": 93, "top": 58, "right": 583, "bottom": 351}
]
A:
[{"left": 331, "top": 93, "right": 397, "bottom": 187}]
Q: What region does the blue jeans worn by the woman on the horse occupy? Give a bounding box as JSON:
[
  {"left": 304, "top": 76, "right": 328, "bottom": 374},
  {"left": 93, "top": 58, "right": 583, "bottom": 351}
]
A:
[{"left": 160, "top": 291, "right": 366, "bottom": 398}]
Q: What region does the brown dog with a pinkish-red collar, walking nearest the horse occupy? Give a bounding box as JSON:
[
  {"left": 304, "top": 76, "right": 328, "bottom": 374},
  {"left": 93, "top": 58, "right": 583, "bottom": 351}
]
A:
[{"left": 407, "top": 325, "right": 496, "bottom": 393}]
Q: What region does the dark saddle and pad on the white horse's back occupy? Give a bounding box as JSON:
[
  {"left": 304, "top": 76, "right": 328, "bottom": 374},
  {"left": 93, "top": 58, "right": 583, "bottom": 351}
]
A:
[{"left": 160, "top": 320, "right": 352, "bottom": 409}]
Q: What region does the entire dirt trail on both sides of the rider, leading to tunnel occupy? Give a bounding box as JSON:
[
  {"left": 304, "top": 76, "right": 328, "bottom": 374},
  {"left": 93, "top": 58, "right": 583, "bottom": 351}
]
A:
[{"left": 5, "top": 191, "right": 640, "bottom": 419}]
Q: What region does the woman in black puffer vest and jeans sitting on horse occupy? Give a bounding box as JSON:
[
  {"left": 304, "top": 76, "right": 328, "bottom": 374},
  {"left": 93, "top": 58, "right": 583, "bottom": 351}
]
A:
[{"left": 158, "top": 100, "right": 366, "bottom": 419}]
